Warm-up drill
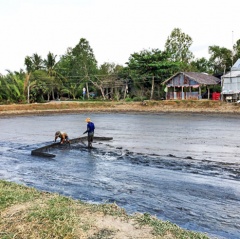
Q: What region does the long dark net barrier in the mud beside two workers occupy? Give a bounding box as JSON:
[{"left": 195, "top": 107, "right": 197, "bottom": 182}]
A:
[{"left": 31, "top": 136, "right": 113, "bottom": 158}]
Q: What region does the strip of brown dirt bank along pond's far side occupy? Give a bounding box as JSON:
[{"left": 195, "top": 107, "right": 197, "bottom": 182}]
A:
[{"left": 0, "top": 100, "right": 240, "bottom": 116}]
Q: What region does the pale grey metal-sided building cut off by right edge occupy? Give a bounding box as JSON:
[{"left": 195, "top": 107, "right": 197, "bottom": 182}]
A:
[{"left": 221, "top": 59, "right": 240, "bottom": 101}]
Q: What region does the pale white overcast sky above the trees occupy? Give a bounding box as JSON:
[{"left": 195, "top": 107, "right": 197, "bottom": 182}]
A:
[{"left": 0, "top": 0, "right": 240, "bottom": 75}]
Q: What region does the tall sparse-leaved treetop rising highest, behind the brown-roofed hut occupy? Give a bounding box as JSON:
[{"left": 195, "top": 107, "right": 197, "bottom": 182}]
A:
[{"left": 165, "top": 28, "right": 193, "bottom": 70}]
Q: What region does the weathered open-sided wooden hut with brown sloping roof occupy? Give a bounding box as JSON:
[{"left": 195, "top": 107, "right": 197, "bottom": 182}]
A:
[{"left": 162, "top": 72, "right": 220, "bottom": 100}]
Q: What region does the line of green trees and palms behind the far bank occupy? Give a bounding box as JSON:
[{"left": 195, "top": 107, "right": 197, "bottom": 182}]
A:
[{"left": 0, "top": 28, "right": 240, "bottom": 103}]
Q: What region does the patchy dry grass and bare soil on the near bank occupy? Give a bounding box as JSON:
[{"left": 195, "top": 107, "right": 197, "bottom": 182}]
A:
[{"left": 0, "top": 180, "right": 208, "bottom": 239}]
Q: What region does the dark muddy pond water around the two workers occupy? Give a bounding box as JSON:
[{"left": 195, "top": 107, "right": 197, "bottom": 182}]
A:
[{"left": 0, "top": 113, "right": 240, "bottom": 239}]
